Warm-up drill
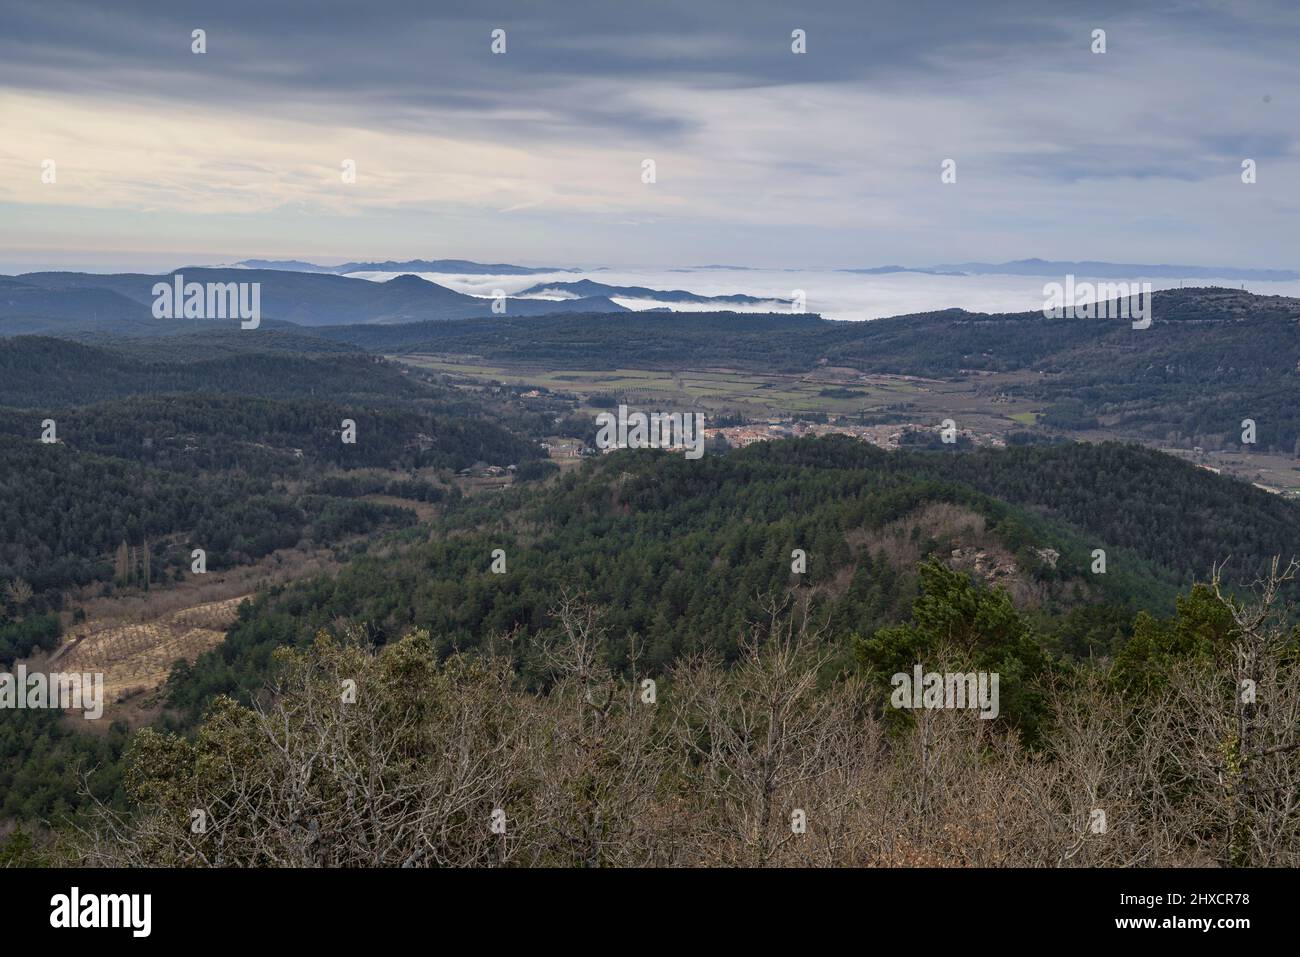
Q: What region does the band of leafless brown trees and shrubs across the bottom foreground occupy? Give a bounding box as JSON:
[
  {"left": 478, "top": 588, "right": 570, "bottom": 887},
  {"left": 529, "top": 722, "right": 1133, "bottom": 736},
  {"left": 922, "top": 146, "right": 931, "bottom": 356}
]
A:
[{"left": 72, "top": 563, "right": 1300, "bottom": 867}]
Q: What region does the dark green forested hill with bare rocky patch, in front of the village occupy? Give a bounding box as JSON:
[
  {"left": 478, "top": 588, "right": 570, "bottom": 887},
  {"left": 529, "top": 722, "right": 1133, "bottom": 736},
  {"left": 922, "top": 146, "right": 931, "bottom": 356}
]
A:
[{"left": 173, "top": 437, "right": 1300, "bottom": 709}]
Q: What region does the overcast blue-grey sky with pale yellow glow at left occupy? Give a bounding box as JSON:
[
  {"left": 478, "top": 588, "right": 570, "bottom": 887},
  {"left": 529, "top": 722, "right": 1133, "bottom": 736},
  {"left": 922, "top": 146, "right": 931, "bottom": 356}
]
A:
[{"left": 0, "top": 0, "right": 1300, "bottom": 272}]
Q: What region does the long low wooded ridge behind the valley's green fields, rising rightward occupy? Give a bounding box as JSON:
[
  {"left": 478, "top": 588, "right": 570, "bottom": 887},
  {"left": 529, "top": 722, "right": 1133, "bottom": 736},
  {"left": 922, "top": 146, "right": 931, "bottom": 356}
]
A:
[{"left": 306, "top": 289, "right": 1300, "bottom": 377}]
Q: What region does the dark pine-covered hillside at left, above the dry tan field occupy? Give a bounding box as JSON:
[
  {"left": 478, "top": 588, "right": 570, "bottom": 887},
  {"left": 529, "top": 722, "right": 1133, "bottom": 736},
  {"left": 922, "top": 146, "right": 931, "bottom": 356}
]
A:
[{"left": 0, "top": 333, "right": 551, "bottom": 605}]
